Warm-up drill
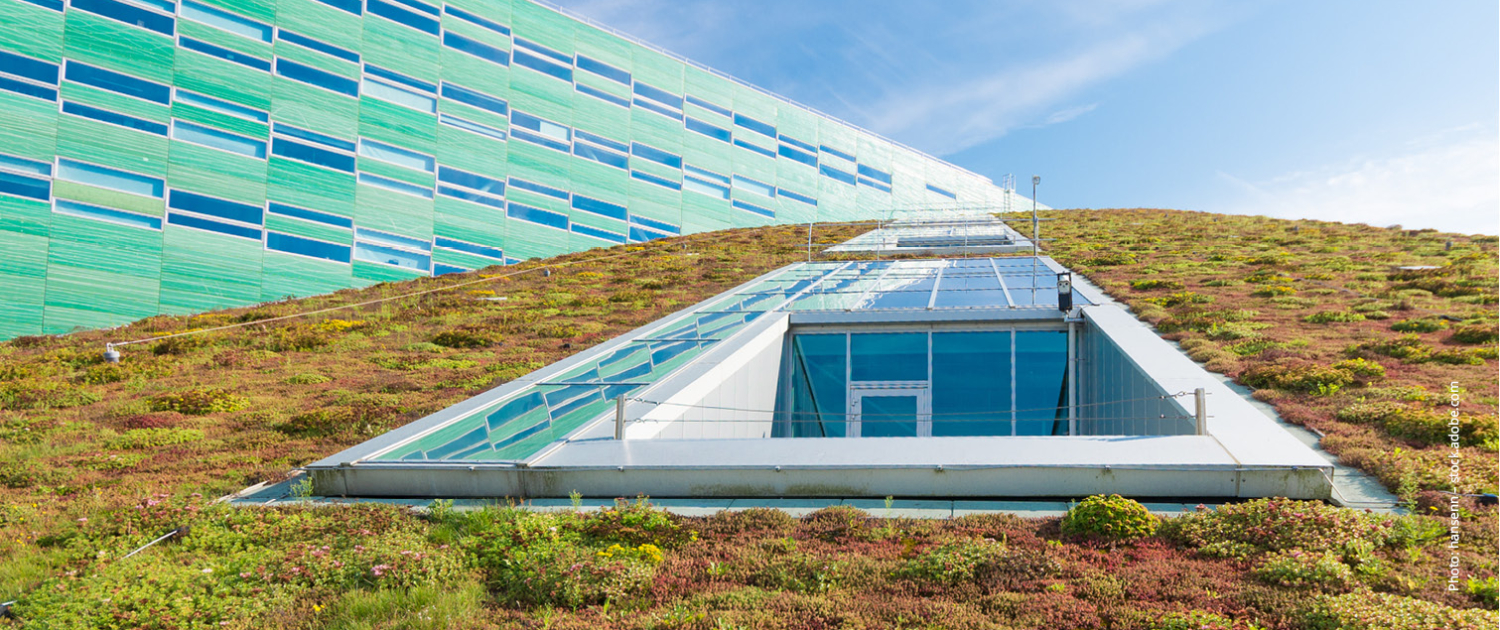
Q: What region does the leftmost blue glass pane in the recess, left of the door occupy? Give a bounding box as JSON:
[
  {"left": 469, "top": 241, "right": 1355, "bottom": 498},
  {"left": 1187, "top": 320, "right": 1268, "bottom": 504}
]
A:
[{"left": 782, "top": 335, "right": 849, "bottom": 438}]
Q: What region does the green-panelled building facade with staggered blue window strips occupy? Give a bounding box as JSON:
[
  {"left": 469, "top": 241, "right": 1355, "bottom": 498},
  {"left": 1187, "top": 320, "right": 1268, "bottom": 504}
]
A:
[{"left": 0, "top": 0, "right": 1005, "bottom": 339}]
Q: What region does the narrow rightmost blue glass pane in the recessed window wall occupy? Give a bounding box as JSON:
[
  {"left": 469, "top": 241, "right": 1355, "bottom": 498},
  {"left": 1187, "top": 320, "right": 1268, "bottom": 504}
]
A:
[{"left": 1016, "top": 330, "right": 1068, "bottom": 435}]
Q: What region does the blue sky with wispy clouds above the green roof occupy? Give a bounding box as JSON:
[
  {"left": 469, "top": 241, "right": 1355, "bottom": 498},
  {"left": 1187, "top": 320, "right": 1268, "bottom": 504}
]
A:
[{"left": 555, "top": 0, "right": 1500, "bottom": 234}]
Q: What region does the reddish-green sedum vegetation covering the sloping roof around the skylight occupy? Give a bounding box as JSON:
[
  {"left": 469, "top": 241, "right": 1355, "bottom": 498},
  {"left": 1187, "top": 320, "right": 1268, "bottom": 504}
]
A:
[{"left": 0, "top": 210, "right": 1497, "bottom": 630}]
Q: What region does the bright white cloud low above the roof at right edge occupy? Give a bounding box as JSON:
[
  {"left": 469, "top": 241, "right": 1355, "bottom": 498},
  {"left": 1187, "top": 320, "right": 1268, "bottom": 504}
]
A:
[{"left": 1211, "top": 128, "right": 1500, "bottom": 234}]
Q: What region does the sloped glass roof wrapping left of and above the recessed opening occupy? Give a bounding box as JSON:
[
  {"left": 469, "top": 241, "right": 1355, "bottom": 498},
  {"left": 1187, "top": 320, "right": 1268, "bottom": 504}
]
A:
[{"left": 369, "top": 257, "right": 1088, "bottom": 462}]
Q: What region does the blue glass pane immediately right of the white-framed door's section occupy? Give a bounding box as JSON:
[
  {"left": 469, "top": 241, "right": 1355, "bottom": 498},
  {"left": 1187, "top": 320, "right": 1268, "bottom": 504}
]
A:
[{"left": 932, "top": 332, "right": 1011, "bottom": 437}]
